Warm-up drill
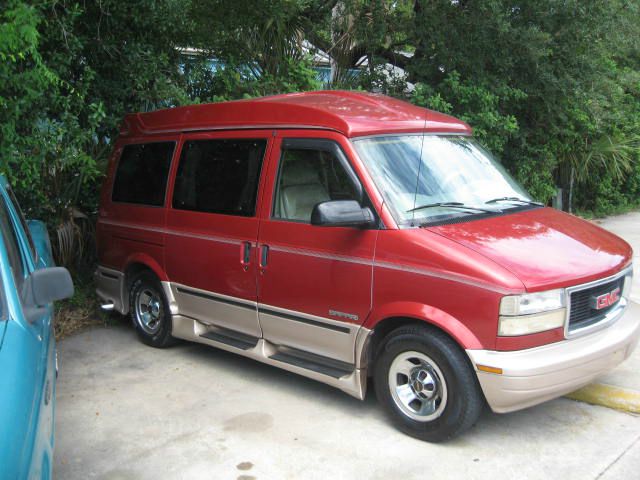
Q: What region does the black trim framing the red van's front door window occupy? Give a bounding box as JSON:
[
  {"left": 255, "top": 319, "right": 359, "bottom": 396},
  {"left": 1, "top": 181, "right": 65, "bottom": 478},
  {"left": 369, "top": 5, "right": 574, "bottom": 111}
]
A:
[{"left": 269, "top": 137, "right": 380, "bottom": 224}]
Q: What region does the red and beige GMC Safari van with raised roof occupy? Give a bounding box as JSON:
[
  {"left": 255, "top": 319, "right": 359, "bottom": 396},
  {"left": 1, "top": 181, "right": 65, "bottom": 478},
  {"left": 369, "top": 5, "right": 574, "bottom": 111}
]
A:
[{"left": 96, "top": 91, "right": 640, "bottom": 441}]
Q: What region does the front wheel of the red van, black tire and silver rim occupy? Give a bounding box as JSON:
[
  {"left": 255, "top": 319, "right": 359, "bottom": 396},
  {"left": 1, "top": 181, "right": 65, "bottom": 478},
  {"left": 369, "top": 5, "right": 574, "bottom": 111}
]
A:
[{"left": 374, "top": 325, "right": 485, "bottom": 442}]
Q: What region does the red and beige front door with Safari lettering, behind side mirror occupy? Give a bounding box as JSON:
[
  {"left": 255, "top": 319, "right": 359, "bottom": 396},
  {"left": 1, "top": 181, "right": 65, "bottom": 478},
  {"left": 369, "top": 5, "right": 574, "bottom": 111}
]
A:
[{"left": 258, "top": 131, "right": 377, "bottom": 371}]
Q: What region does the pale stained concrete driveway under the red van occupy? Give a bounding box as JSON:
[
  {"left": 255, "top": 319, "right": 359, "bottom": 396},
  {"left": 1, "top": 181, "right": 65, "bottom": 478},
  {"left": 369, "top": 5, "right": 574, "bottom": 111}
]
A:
[{"left": 54, "top": 214, "right": 640, "bottom": 480}]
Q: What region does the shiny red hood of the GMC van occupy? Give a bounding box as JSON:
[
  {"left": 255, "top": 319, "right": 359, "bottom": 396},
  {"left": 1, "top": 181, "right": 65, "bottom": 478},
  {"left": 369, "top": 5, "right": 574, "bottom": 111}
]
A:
[{"left": 427, "top": 208, "right": 633, "bottom": 291}]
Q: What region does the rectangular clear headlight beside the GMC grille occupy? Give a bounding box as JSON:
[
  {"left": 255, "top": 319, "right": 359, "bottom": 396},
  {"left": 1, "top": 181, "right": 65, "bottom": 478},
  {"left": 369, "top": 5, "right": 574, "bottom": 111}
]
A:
[{"left": 498, "top": 289, "right": 567, "bottom": 337}]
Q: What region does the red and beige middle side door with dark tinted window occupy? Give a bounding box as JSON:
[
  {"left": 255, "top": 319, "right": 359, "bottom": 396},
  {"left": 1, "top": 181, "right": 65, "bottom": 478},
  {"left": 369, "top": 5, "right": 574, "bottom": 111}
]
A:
[{"left": 166, "top": 131, "right": 271, "bottom": 342}]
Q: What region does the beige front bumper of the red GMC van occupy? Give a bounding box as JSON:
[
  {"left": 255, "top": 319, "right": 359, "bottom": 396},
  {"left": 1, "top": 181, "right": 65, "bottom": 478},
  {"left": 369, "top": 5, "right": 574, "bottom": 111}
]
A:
[{"left": 467, "top": 303, "right": 640, "bottom": 413}]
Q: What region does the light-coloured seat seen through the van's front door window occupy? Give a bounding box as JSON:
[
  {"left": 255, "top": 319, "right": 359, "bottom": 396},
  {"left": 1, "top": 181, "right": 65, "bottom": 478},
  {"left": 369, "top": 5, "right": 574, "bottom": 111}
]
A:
[{"left": 280, "top": 159, "right": 331, "bottom": 222}]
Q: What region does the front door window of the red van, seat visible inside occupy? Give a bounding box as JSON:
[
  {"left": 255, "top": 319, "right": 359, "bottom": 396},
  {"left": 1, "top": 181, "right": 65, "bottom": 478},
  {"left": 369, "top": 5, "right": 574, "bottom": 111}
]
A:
[{"left": 273, "top": 142, "right": 359, "bottom": 223}]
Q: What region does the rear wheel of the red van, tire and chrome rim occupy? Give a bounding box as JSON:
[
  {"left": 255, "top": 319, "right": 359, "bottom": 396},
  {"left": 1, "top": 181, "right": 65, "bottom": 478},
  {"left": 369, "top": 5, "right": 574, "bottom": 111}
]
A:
[{"left": 129, "top": 272, "right": 175, "bottom": 348}]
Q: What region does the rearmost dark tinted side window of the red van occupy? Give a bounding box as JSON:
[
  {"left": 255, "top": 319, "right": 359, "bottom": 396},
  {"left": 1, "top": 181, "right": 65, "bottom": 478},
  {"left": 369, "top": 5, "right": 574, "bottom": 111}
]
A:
[{"left": 111, "top": 142, "right": 175, "bottom": 207}]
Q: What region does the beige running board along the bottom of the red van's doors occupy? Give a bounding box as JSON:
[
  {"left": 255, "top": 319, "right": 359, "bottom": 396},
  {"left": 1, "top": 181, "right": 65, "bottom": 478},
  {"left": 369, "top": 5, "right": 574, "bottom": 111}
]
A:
[{"left": 172, "top": 315, "right": 369, "bottom": 400}]
